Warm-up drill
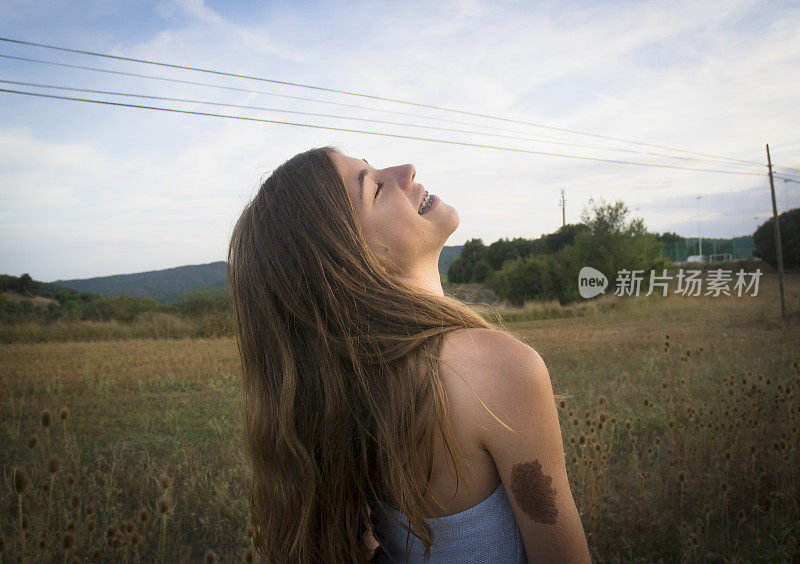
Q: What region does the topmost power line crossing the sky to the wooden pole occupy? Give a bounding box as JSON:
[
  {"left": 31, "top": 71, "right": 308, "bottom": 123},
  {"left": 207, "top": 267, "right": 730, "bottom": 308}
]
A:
[{"left": 0, "top": 37, "right": 776, "bottom": 170}]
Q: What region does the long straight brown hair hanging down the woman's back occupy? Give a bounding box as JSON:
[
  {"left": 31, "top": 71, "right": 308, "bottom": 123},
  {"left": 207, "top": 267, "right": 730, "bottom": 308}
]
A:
[{"left": 228, "top": 147, "right": 520, "bottom": 562}]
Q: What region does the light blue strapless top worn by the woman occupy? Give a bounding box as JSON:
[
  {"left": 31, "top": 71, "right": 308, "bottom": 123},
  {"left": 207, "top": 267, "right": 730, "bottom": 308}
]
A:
[{"left": 370, "top": 482, "right": 527, "bottom": 564}]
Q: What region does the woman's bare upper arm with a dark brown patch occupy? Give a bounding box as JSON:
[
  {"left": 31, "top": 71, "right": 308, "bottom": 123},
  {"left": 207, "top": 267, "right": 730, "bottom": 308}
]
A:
[{"left": 466, "top": 331, "right": 591, "bottom": 562}]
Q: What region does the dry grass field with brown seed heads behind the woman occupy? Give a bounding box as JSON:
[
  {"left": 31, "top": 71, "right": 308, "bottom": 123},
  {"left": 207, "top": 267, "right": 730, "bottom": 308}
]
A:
[{"left": 0, "top": 274, "right": 800, "bottom": 562}]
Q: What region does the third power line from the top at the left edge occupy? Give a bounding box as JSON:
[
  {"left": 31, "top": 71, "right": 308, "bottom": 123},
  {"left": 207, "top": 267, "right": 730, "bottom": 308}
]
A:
[{"left": 0, "top": 79, "right": 776, "bottom": 173}]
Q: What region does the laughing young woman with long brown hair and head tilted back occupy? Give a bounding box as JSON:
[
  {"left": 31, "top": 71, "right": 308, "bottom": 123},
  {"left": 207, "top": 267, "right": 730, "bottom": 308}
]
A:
[{"left": 228, "top": 147, "right": 589, "bottom": 563}]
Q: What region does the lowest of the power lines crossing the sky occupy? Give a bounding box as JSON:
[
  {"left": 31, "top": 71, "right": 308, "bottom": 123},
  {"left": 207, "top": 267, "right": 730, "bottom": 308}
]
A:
[{"left": 0, "top": 88, "right": 764, "bottom": 176}]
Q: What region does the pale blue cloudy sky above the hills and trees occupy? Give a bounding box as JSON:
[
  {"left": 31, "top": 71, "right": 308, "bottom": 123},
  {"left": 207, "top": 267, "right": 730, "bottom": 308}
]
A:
[{"left": 0, "top": 0, "right": 800, "bottom": 281}]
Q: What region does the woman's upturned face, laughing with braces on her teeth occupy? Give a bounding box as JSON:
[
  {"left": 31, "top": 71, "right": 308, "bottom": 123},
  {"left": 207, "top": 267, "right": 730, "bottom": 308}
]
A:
[{"left": 333, "top": 149, "right": 459, "bottom": 275}]
